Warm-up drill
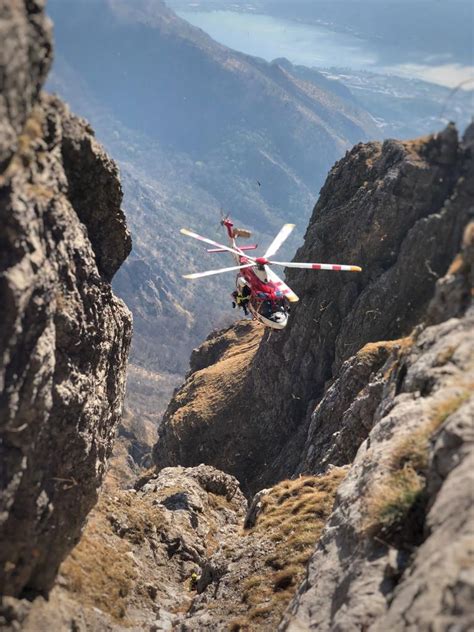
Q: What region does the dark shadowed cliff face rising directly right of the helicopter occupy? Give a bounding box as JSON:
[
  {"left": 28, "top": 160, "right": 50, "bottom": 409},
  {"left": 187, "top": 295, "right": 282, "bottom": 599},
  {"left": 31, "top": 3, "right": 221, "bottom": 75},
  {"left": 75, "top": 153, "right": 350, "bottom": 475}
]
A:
[{"left": 155, "top": 125, "right": 474, "bottom": 493}]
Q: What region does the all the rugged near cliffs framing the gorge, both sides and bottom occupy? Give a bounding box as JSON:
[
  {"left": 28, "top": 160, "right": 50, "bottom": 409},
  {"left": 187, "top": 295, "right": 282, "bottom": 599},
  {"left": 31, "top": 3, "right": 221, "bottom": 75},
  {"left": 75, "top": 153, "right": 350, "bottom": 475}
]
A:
[{"left": 0, "top": 0, "right": 474, "bottom": 632}]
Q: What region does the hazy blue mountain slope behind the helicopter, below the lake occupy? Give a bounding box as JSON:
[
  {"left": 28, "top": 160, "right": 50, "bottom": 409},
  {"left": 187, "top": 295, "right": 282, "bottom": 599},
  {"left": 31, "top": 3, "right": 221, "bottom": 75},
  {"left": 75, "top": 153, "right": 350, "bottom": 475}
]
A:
[{"left": 44, "top": 0, "right": 377, "bottom": 390}]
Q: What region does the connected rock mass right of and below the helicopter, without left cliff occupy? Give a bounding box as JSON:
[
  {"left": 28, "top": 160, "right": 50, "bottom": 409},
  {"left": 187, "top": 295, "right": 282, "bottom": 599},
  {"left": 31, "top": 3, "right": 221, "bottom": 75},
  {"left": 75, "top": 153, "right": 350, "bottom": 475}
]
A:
[{"left": 0, "top": 110, "right": 474, "bottom": 632}]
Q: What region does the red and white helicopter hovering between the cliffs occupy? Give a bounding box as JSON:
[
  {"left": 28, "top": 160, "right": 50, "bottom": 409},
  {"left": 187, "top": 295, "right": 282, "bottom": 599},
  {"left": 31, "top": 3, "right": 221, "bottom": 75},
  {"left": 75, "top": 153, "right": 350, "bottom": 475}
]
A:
[{"left": 180, "top": 218, "right": 362, "bottom": 329}]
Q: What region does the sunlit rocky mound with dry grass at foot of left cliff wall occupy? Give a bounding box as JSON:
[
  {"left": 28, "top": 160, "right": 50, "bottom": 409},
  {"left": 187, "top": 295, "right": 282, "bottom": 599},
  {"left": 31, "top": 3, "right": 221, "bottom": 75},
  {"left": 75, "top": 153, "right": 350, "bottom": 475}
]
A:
[{"left": 0, "top": 465, "right": 246, "bottom": 632}]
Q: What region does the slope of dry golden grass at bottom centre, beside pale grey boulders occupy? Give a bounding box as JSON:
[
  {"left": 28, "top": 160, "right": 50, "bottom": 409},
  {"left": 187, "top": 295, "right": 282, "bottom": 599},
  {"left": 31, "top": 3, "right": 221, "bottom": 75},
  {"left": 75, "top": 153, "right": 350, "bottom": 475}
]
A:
[{"left": 177, "top": 468, "right": 347, "bottom": 632}]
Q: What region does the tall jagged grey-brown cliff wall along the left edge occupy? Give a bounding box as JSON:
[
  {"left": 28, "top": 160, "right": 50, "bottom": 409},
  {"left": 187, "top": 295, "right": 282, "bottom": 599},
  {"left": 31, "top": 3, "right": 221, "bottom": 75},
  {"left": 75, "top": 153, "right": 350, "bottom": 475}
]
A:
[{"left": 0, "top": 0, "right": 131, "bottom": 595}]
